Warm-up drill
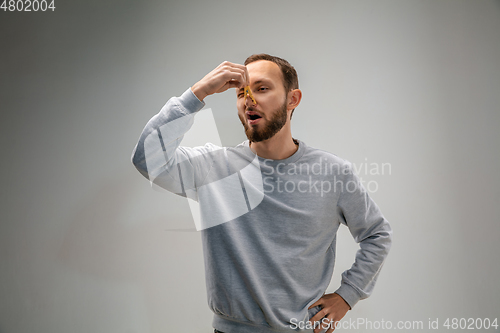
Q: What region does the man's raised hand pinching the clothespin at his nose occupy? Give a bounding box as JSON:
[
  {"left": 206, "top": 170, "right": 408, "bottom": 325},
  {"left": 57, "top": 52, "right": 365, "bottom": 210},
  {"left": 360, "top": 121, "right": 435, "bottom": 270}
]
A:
[{"left": 191, "top": 61, "right": 249, "bottom": 101}]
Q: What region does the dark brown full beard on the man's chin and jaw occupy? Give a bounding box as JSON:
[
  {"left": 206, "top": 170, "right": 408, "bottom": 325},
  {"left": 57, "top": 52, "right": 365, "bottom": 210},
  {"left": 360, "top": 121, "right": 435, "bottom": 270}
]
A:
[{"left": 239, "top": 100, "right": 287, "bottom": 142}]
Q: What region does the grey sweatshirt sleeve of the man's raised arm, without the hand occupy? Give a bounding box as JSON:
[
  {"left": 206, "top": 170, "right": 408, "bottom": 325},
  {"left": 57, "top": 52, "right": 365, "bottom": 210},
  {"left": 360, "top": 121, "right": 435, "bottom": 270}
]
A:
[{"left": 131, "top": 88, "right": 215, "bottom": 200}]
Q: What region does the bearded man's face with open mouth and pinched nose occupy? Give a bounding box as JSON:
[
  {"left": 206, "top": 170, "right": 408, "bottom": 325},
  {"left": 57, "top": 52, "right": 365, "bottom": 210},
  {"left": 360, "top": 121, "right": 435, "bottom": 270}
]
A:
[{"left": 236, "top": 60, "right": 288, "bottom": 142}]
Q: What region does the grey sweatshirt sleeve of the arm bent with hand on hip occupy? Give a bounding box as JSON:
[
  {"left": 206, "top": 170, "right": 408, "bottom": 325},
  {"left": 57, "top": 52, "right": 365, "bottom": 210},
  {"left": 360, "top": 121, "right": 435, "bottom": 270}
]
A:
[{"left": 335, "top": 164, "right": 392, "bottom": 309}]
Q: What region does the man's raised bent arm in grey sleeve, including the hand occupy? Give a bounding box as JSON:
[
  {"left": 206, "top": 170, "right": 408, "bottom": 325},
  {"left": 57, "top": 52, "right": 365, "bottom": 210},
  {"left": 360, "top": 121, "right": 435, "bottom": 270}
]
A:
[{"left": 132, "top": 62, "right": 248, "bottom": 195}]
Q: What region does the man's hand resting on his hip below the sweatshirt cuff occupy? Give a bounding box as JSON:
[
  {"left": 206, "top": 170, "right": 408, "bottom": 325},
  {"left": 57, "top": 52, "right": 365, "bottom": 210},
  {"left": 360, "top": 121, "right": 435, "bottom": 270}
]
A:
[{"left": 309, "top": 293, "right": 351, "bottom": 333}]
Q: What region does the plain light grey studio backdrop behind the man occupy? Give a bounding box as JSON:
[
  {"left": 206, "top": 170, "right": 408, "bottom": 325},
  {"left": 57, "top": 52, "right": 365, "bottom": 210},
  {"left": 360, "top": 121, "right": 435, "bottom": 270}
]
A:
[{"left": 0, "top": 0, "right": 500, "bottom": 333}]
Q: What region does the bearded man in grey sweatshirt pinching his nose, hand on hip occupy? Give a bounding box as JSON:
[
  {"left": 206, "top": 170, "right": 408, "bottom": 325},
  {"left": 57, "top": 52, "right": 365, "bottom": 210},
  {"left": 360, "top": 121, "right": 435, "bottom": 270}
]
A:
[{"left": 132, "top": 54, "right": 392, "bottom": 333}]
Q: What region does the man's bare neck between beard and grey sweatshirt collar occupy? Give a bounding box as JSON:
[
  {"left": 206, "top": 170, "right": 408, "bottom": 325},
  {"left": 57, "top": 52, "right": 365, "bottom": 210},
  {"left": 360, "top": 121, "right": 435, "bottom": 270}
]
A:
[{"left": 250, "top": 127, "right": 298, "bottom": 160}]
